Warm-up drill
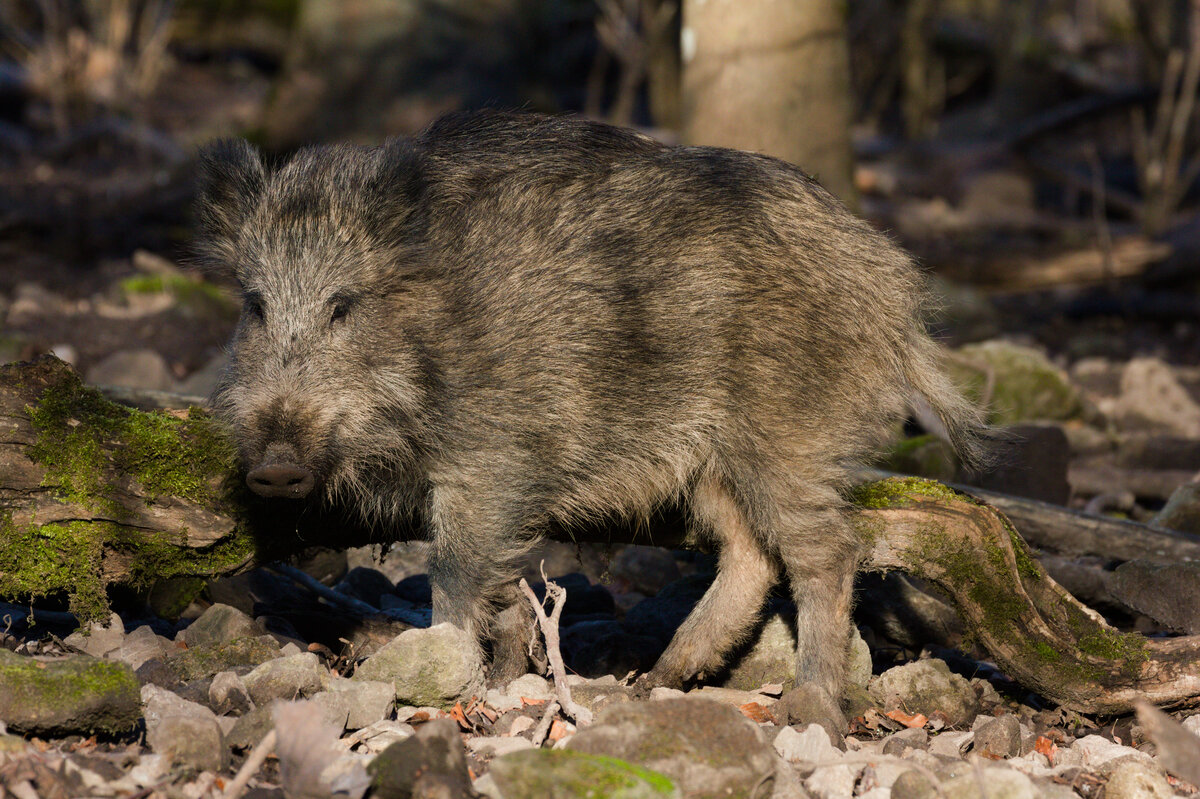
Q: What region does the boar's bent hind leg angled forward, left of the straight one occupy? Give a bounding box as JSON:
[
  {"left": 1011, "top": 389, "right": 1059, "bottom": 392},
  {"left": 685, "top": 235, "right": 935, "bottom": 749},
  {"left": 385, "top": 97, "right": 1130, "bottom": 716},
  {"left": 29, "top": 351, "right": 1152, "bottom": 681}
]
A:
[{"left": 647, "top": 476, "right": 778, "bottom": 687}]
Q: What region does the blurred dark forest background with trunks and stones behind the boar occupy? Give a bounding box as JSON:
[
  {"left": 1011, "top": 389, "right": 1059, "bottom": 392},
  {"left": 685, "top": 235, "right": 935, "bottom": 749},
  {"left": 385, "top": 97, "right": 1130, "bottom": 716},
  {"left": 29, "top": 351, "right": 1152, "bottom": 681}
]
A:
[{"left": 0, "top": 0, "right": 1200, "bottom": 518}]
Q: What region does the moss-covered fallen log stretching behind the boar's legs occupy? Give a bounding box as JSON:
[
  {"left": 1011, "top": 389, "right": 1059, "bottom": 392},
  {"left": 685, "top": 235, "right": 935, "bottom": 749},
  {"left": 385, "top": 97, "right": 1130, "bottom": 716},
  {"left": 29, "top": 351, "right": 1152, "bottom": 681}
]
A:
[{"left": 0, "top": 358, "right": 1200, "bottom": 714}]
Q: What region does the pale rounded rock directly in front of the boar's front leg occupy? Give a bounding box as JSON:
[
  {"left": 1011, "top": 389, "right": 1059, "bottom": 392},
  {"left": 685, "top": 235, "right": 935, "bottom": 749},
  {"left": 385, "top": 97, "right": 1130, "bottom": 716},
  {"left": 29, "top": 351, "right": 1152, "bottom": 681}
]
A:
[{"left": 353, "top": 624, "right": 484, "bottom": 708}]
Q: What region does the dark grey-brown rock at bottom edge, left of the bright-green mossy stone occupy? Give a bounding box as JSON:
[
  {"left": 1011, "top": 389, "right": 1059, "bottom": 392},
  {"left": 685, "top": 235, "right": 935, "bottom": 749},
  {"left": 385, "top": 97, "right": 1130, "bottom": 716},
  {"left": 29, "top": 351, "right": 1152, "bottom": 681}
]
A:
[{"left": 367, "top": 719, "right": 470, "bottom": 799}]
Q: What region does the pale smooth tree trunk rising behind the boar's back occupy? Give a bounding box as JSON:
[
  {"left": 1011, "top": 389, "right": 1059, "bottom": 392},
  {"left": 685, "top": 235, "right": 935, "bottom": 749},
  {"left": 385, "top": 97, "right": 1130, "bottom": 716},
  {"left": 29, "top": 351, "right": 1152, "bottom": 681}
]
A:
[{"left": 680, "top": 0, "right": 858, "bottom": 208}]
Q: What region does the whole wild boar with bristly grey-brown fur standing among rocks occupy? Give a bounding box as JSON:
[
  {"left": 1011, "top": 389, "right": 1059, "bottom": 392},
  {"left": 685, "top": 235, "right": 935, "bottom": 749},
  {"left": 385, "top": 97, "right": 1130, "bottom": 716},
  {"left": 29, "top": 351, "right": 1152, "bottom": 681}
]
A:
[{"left": 199, "top": 112, "right": 982, "bottom": 691}]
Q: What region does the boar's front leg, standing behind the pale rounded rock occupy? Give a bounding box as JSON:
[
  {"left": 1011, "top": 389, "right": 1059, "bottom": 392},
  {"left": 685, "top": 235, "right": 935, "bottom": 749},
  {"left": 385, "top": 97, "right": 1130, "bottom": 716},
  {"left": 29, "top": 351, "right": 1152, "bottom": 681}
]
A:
[{"left": 428, "top": 489, "right": 538, "bottom": 685}]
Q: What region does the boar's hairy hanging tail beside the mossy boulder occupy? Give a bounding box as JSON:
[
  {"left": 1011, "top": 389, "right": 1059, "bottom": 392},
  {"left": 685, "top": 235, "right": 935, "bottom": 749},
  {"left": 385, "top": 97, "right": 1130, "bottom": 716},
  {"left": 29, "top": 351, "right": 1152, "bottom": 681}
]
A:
[{"left": 904, "top": 331, "right": 992, "bottom": 471}]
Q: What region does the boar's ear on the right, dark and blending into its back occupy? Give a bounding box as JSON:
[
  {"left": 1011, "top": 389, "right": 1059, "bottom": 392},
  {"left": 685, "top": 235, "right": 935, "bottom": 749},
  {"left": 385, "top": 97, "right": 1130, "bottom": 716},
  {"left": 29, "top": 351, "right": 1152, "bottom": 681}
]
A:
[{"left": 367, "top": 138, "right": 426, "bottom": 242}]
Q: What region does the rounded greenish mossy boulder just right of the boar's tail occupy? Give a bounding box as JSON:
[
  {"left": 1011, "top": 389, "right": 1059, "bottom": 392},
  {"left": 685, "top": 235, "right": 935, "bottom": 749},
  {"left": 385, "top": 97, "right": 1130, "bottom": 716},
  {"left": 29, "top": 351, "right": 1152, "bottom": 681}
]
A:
[{"left": 948, "top": 340, "right": 1082, "bottom": 425}]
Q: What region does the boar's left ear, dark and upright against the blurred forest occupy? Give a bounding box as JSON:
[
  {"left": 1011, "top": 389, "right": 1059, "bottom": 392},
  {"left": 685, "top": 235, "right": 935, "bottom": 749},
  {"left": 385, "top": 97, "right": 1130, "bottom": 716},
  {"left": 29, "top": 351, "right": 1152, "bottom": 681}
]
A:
[{"left": 196, "top": 139, "right": 266, "bottom": 268}]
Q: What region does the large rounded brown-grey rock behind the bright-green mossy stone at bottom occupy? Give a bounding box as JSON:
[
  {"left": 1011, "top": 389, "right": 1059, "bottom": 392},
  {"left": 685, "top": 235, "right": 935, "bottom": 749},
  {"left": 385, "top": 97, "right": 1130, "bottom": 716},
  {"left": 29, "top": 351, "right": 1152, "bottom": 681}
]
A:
[{"left": 566, "top": 698, "right": 772, "bottom": 799}]
